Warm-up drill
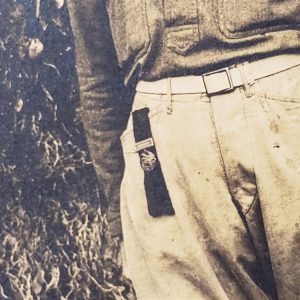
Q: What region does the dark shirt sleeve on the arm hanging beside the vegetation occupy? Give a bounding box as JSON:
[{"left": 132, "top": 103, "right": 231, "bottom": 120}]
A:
[{"left": 68, "top": 0, "right": 128, "bottom": 236}]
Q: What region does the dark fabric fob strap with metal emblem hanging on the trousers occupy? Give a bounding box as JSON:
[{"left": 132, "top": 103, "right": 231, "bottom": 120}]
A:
[{"left": 132, "top": 107, "right": 175, "bottom": 217}]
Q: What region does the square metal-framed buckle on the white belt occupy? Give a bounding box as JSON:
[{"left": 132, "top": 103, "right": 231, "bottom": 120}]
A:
[{"left": 202, "top": 68, "right": 234, "bottom": 95}]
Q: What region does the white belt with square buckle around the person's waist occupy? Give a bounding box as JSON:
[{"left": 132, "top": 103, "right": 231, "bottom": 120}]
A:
[{"left": 136, "top": 54, "right": 300, "bottom": 95}]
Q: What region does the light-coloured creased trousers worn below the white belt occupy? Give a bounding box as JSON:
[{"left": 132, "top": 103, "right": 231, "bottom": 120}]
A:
[{"left": 121, "top": 56, "right": 300, "bottom": 300}]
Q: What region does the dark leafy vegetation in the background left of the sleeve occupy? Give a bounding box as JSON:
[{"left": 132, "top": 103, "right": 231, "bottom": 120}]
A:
[{"left": 0, "top": 0, "right": 135, "bottom": 300}]
